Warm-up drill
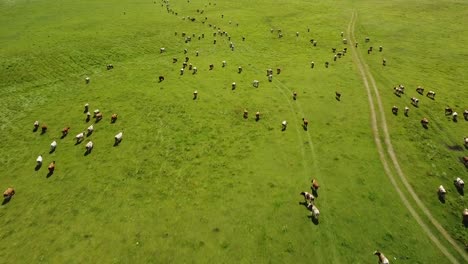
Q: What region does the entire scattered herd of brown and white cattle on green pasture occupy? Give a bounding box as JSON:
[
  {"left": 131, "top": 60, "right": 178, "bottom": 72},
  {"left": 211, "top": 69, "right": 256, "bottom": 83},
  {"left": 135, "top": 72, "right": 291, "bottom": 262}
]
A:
[{"left": 4, "top": 0, "right": 468, "bottom": 263}]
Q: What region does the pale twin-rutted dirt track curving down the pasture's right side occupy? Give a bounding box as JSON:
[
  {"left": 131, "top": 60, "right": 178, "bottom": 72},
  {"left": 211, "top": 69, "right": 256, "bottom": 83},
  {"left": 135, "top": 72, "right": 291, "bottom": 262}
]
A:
[{"left": 347, "top": 12, "right": 462, "bottom": 263}]
